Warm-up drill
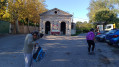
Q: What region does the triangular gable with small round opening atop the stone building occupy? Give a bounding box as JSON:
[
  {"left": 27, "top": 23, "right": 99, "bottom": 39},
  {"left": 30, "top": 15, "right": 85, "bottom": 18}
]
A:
[{"left": 40, "top": 8, "right": 72, "bottom": 16}]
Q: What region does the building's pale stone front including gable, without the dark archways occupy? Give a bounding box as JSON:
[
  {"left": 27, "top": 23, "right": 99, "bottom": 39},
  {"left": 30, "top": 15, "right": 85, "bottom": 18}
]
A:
[{"left": 40, "top": 8, "right": 72, "bottom": 35}]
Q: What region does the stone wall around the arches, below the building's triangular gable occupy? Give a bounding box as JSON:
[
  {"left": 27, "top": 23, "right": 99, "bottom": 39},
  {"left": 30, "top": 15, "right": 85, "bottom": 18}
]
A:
[{"left": 40, "top": 16, "right": 71, "bottom": 35}]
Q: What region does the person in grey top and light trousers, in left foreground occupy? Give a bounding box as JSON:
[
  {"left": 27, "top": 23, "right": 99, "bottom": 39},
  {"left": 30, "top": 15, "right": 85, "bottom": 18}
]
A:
[{"left": 23, "top": 32, "right": 38, "bottom": 67}]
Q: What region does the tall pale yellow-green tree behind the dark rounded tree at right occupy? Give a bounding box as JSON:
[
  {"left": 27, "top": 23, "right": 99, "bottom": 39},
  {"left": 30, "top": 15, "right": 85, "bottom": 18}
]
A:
[{"left": 88, "top": 0, "right": 116, "bottom": 22}]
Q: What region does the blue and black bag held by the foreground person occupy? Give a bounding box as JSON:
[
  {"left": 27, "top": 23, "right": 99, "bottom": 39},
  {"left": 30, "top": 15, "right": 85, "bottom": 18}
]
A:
[{"left": 33, "top": 47, "right": 45, "bottom": 62}]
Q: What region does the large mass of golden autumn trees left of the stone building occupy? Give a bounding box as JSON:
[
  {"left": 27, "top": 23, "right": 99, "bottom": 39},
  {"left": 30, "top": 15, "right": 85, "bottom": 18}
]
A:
[{"left": 8, "top": 0, "right": 46, "bottom": 33}]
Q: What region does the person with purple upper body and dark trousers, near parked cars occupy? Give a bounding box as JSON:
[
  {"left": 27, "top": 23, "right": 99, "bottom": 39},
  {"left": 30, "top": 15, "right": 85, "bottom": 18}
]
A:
[{"left": 86, "top": 28, "right": 95, "bottom": 54}]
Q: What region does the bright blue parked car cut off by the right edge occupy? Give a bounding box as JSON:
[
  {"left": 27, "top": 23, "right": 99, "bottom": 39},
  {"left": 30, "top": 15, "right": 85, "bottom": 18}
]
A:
[{"left": 105, "top": 29, "right": 119, "bottom": 46}]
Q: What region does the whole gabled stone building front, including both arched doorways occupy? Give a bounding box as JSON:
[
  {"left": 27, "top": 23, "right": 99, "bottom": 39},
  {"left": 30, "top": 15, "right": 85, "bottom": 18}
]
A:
[{"left": 40, "top": 8, "right": 72, "bottom": 35}]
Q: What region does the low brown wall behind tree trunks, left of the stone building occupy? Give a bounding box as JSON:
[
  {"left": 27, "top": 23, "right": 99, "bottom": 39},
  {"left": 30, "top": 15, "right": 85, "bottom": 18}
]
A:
[{"left": 19, "top": 25, "right": 39, "bottom": 34}]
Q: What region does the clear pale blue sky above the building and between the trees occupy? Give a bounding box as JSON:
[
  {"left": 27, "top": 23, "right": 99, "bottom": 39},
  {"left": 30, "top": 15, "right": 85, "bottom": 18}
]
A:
[{"left": 45, "top": 0, "right": 90, "bottom": 22}]
